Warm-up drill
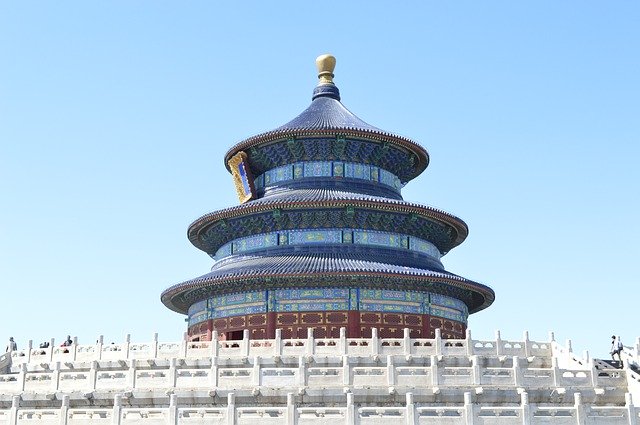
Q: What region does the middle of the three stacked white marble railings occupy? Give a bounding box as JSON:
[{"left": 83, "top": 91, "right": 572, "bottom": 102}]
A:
[{"left": 0, "top": 354, "right": 626, "bottom": 394}]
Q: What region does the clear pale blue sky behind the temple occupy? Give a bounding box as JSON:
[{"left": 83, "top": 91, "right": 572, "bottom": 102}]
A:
[{"left": 0, "top": 0, "right": 640, "bottom": 356}]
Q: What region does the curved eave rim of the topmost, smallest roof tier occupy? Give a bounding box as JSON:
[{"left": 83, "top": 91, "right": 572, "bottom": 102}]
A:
[{"left": 224, "top": 127, "right": 429, "bottom": 178}]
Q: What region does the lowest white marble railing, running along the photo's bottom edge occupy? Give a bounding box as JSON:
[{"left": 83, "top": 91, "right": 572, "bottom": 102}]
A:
[{"left": 0, "top": 392, "right": 640, "bottom": 425}]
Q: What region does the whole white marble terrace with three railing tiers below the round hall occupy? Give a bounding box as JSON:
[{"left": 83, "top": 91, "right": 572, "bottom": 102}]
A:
[{"left": 0, "top": 329, "right": 640, "bottom": 425}]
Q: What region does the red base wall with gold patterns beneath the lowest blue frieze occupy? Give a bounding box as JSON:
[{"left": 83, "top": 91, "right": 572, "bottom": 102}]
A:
[{"left": 188, "top": 311, "right": 467, "bottom": 341}]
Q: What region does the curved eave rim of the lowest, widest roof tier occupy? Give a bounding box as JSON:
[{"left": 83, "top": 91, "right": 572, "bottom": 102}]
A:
[{"left": 160, "top": 271, "right": 495, "bottom": 314}]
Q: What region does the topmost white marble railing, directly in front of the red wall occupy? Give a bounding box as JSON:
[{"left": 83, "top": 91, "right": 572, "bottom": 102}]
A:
[{"left": 6, "top": 328, "right": 553, "bottom": 367}]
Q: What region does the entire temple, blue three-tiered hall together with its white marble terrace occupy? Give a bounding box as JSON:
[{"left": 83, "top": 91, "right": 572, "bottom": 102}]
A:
[{"left": 0, "top": 55, "right": 640, "bottom": 425}]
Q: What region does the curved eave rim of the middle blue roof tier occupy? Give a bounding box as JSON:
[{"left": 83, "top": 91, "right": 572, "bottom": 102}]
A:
[{"left": 187, "top": 198, "right": 469, "bottom": 250}]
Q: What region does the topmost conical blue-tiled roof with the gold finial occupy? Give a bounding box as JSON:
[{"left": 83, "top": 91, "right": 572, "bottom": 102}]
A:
[{"left": 224, "top": 55, "right": 429, "bottom": 178}]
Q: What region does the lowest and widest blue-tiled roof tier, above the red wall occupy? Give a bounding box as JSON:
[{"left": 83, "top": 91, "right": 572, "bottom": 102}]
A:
[{"left": 161, "top": 253, "right": 495, "bottom": 314}]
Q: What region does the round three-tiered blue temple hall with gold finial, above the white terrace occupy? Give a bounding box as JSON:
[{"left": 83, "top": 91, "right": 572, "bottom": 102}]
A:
[{"left": 162, "top": 55, "right": 494, "bottom": 341}]
